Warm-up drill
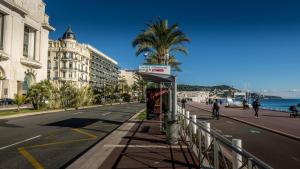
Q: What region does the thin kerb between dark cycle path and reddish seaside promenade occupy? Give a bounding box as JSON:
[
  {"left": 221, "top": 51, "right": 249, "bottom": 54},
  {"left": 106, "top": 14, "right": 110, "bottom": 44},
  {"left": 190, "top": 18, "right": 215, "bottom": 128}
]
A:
[{"left": 189, "top": 104, "right": 300, "bottom": 141}]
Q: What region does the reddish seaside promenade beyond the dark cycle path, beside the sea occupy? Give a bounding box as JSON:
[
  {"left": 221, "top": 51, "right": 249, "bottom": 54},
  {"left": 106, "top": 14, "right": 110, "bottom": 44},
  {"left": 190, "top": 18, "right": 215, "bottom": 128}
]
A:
[{"left": 188, "top": 102, "right": 300, "bottom": 140}]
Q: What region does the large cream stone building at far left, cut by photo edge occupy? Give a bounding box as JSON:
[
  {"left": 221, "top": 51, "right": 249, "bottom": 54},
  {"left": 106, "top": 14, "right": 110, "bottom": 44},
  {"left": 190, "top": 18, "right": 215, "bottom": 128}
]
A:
[{"left": 0, "top": 0, "right": 54, "bottom": 98}]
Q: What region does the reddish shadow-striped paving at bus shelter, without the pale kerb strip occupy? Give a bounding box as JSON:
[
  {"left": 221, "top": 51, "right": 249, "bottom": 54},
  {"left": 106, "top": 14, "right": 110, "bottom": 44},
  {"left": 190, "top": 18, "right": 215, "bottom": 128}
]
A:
[{"left": 100, "top": 121, "right": 198, "bottom": 169}]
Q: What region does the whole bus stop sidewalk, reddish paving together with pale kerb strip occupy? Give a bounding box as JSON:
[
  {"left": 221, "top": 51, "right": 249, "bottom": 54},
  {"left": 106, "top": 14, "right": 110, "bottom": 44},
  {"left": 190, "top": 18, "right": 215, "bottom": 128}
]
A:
[{"left": 68, "top": 111, "right": 198, "bottom": 169}]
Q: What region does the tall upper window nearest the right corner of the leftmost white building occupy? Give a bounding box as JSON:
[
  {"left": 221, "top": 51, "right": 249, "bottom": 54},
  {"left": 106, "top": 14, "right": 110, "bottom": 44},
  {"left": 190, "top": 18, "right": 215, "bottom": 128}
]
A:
[{"left": 23, "top": 26, "right": 35, "bottom": 60}]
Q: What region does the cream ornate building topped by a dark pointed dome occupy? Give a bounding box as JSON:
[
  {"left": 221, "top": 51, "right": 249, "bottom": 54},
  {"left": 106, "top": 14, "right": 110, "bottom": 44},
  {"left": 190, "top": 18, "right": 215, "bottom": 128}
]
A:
[{"left": 47, "top": 26, "right": 90, "bottom": 86}]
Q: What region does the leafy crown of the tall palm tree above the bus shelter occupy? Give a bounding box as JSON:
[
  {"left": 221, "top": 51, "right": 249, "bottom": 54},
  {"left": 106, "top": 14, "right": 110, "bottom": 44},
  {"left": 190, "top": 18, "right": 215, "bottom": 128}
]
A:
[{"left": 132, "top": 19, "right": 190, "bottom": 70}]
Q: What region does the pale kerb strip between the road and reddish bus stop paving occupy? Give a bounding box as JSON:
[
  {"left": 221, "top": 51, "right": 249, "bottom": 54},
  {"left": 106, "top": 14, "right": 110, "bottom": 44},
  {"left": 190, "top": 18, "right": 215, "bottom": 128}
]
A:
[{"left": 63, "top": 108, "right": 145, "bottom": 169}]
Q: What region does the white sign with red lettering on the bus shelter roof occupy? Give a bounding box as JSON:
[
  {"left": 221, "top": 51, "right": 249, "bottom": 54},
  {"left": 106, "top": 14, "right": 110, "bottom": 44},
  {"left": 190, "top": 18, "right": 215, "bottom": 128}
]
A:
[{"left": 139, "top": 65, "right": 171, "bottom": 75}]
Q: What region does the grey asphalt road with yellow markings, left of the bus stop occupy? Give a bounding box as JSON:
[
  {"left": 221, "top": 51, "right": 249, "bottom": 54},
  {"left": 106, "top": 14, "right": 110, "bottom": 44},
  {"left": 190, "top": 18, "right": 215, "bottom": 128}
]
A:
[{"left": 0, "top": 104, "right": 145, "bottom": 169}]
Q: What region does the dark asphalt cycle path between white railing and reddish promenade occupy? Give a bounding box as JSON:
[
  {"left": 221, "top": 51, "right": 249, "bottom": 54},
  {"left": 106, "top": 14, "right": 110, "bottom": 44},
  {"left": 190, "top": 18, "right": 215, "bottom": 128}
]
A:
[{"left": 187, "top": 105, "right": 300, "bottom": 169}]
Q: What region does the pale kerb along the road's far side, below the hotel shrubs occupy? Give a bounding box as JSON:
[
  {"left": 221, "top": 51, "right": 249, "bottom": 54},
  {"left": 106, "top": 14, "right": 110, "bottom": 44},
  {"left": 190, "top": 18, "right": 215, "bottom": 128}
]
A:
[{"left": 0, "top": 103, "right": 129, "bottom": 120}]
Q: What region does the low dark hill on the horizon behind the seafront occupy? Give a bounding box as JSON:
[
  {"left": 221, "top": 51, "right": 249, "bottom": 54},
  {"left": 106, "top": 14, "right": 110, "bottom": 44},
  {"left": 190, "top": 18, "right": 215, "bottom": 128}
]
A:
[{"left": 177, "top": 84, "right": 238, "bottom": 91}]
